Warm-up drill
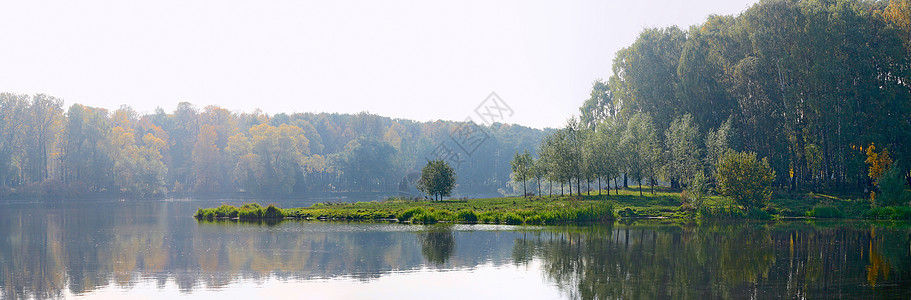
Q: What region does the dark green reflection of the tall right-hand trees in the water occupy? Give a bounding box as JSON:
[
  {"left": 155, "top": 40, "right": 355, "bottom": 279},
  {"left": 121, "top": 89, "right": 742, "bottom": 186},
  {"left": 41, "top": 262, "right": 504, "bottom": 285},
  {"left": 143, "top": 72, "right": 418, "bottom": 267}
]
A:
[{"left": 513, "top": 222, "right": 911, "bottom": 299}]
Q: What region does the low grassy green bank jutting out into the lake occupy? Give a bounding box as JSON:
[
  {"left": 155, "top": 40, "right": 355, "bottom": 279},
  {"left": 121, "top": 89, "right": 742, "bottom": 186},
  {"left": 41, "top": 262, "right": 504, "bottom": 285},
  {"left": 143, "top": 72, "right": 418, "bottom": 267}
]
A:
[{"left": 195, "top": 187, "right": 911, "bottom": 225}]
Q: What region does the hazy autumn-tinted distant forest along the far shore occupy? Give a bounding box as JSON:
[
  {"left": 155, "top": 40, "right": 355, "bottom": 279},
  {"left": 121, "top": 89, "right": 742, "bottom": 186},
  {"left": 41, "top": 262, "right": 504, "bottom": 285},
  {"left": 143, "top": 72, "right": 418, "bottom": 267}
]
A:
[{"left": 0, "top": 93, "right": 543, "bottom": 197}]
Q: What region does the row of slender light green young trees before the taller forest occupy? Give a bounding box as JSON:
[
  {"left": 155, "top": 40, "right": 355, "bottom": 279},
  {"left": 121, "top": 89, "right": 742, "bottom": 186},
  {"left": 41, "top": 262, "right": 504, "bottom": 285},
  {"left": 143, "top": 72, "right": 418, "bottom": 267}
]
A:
[{"left": 512, "top": 113, "right": 732, "bottom": 195}]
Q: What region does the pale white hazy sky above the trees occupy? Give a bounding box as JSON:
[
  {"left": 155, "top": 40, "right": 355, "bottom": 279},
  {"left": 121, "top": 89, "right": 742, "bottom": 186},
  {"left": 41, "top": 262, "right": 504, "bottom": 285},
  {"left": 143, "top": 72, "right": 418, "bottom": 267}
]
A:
[{"left": 0, "top": 0, "right": 757, "bottom": 128}]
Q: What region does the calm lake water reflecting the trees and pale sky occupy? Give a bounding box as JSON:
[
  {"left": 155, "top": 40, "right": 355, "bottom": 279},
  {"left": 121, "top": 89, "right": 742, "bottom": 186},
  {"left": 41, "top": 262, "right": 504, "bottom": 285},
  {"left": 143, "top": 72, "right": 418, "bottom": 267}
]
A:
[{"left": 0, "top": 200, "right": 911, "bottom": 299}]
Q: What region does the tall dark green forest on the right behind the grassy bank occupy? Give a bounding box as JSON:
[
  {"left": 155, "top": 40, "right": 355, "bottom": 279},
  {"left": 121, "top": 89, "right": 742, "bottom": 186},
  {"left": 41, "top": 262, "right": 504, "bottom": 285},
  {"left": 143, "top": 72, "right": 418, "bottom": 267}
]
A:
[{"left": 513, "top": 0, "right": 911, "bottom": 198}]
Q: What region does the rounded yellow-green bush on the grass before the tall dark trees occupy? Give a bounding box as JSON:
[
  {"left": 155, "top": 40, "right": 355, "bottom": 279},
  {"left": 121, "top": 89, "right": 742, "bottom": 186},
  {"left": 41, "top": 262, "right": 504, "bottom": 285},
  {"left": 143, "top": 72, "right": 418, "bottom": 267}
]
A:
[{"left": 715, "top": 152, "right": 775, "bottom": 210}]
